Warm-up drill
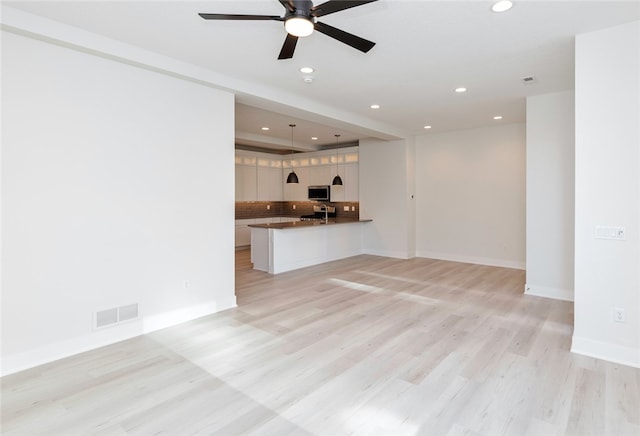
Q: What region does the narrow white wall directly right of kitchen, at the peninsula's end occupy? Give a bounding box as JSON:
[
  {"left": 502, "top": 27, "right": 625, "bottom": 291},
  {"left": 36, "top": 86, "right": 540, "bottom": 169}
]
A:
[{"left": 359, "top": 139, "right": 413, "bottom": 259}]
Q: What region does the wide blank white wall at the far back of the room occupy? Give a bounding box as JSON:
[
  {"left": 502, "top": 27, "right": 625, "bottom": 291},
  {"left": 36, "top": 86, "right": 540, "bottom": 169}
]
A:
[{"left": 416, "top": 124, "right": 525, "bottom": 269}]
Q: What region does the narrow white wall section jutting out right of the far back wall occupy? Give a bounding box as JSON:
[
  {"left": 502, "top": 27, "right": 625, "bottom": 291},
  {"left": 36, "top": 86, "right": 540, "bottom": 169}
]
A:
[{"left": 525, "top": 90, "right": 575, "bottom": 301}]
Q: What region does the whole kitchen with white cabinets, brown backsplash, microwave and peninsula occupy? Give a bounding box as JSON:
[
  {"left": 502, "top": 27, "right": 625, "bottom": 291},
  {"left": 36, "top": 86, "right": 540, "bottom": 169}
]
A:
[{"left": 235, "top": 147, "right": 370, "bottom": 274}]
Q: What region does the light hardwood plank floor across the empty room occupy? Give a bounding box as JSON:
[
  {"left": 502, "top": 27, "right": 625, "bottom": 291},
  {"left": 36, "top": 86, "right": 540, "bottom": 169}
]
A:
[{"left": 2, "top": 251, "right": 640, "bottom": 436}]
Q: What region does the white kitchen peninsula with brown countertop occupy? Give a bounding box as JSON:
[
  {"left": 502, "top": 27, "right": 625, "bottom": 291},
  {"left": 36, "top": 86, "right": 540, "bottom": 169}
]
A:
[{"left": 249, "top": 218, "right": 371, "bottom": 274}]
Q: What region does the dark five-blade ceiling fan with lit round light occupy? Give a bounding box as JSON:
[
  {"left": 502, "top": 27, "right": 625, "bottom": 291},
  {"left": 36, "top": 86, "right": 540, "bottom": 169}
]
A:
[{"left": 198, "top": 0, "right": 377, "bottom": 59}]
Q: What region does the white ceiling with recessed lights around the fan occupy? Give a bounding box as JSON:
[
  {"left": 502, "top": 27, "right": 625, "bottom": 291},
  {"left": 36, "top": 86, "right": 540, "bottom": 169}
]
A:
[{"left": 3, "top": 0, "right": 640, "bottom": 149}]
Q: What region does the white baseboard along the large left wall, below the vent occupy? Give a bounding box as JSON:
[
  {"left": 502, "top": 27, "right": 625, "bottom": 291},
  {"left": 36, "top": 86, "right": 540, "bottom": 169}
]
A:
[{"left": 0, "top": 295, "right": 236, "bottom": 376}]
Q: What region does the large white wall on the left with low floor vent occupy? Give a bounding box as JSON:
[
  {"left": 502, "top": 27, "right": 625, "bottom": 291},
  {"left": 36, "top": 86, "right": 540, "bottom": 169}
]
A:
[{"left": 2, "top": 32, "right": 235, "bottom": 374}]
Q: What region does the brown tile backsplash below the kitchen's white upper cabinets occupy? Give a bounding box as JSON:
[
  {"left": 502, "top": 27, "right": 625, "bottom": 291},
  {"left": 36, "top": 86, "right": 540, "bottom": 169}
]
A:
[{"left": 236, "top": 201, "right": 360, "bottom": 220}]
